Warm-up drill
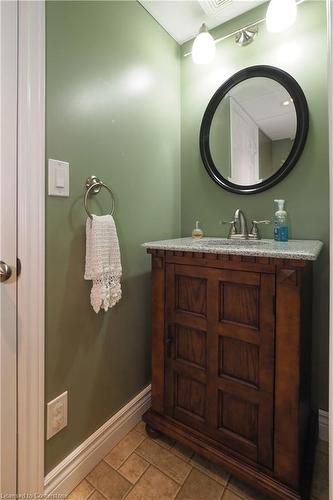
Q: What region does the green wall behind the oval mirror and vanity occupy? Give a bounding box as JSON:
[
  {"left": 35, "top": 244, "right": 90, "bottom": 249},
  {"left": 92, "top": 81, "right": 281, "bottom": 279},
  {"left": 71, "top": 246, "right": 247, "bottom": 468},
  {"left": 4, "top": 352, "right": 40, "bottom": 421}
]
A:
[{"left": 181, "top": 1, "right": 329, "bottom": 409}]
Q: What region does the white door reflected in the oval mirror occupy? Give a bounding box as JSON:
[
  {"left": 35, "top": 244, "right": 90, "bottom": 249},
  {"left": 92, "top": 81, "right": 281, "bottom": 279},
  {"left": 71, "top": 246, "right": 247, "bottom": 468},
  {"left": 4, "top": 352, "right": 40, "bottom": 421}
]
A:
[{"left": 229, "top": 97, "right": 260, "bottom": 186}]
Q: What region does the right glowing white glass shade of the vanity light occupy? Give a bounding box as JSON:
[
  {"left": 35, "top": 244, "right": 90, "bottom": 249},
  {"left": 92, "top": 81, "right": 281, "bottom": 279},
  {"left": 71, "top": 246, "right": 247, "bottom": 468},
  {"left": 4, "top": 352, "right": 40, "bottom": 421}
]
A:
[{"left": 266, "top": 0, "right": 297, "bottom": 33}]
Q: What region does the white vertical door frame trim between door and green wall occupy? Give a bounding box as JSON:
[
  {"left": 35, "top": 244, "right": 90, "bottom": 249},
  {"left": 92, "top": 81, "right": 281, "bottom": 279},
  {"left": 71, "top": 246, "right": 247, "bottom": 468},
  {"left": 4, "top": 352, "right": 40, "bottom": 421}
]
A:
[{"left": 17, "top": 0, "right": 45, "bottom": 494}]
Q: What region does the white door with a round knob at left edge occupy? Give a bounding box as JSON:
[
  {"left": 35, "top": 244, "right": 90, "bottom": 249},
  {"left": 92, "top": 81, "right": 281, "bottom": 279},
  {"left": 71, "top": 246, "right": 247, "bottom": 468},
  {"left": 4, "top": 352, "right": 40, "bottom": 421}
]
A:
[{"left": 0, "top": 1, "right": 18, "bottom": 495}]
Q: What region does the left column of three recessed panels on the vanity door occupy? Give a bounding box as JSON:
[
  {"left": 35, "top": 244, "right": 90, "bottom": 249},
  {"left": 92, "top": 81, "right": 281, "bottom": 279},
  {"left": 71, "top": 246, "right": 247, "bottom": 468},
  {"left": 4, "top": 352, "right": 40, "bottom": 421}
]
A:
[{"left": 165, "top": 264, "right": 210, "bottom": 431}]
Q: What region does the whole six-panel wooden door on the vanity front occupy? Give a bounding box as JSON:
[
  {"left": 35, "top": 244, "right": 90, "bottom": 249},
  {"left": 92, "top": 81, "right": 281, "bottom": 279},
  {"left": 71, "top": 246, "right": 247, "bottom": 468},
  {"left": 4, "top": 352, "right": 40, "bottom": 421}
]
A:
[{"left": 165, "top": 264, "right": 275, "bottom": 467}]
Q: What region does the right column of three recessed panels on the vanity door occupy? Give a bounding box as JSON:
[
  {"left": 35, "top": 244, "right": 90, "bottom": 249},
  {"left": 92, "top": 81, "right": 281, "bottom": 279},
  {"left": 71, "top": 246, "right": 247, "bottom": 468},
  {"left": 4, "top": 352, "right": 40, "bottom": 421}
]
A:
[{"left": 208, "top": 272, "right": 275, "bottom": 468}]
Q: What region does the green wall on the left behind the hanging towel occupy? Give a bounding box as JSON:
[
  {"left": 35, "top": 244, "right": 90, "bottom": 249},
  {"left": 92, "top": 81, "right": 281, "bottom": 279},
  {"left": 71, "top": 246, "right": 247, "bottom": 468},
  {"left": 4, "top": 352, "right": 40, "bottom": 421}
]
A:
[{"left": 45, "top": 1, "right": 180, "bottom": 472}]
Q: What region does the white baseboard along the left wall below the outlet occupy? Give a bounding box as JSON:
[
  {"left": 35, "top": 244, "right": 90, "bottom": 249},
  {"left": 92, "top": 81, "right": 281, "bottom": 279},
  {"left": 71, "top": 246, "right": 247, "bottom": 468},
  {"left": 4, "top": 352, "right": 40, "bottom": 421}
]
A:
[{"left": 44, "top": 385, "right": 151, "bottom": 495}]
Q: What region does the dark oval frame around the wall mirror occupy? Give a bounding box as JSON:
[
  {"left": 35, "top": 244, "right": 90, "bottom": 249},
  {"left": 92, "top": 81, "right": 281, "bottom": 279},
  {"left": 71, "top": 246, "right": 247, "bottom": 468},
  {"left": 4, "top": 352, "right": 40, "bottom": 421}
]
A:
[{"left": 199, "top": 66, "right": 309, "bottom": 194}]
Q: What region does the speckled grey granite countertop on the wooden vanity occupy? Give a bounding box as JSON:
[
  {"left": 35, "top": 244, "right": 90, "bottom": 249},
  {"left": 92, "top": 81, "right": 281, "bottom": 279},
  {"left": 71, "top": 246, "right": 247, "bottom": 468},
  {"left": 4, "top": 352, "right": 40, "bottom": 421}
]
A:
[{"left": 142, "top": 237, "right": 323, "bottom": 260}]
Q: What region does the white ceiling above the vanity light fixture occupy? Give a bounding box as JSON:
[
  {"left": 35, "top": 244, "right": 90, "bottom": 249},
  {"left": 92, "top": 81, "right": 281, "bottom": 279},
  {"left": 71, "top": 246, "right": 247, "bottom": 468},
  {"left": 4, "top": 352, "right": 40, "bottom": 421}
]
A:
[{"left": 139, "top": 0, "right": 267, "bottom": 44}]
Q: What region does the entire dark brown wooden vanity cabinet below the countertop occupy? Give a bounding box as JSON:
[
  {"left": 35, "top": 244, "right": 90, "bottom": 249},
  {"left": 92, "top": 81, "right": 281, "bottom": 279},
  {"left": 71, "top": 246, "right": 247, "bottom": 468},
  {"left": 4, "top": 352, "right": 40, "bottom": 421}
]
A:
[{"left": 144, "top": 250, "right": 317, "bottom": 499}]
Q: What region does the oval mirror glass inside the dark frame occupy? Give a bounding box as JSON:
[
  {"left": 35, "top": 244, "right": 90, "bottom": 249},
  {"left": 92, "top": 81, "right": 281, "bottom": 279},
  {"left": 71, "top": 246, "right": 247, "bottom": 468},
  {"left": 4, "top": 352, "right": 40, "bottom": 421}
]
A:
[{"left": 209, "top": 77, "right": 297, "bottom": 186}]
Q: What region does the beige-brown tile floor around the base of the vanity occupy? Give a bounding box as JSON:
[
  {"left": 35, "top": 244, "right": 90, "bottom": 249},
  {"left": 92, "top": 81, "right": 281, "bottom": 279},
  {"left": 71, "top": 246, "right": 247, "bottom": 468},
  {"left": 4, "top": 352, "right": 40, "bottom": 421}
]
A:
[{"left": 68, "top": 422, "right": 328, "bottom": 500}]
